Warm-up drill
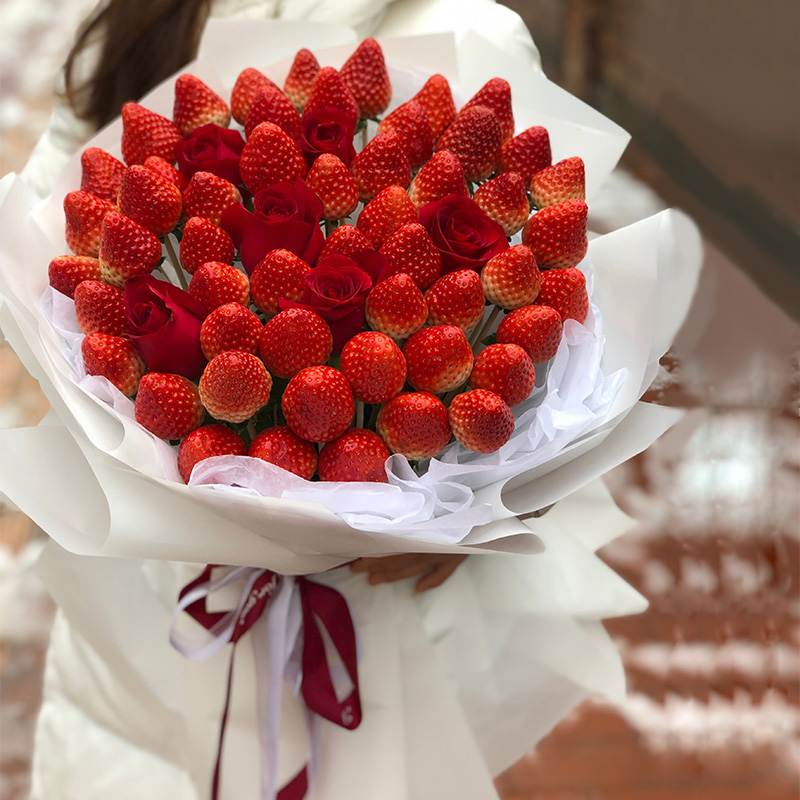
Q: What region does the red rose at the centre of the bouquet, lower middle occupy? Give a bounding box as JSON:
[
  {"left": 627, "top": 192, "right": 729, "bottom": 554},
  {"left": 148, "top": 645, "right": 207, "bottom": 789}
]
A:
[{"left": 278, "top": 255, "right": 372, "bottom": 355}]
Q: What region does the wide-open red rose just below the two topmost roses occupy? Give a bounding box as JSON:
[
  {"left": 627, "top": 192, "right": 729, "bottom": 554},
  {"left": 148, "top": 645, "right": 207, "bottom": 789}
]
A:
[{"left": 220, "top": 178, "right": 325, "bottom": 275}]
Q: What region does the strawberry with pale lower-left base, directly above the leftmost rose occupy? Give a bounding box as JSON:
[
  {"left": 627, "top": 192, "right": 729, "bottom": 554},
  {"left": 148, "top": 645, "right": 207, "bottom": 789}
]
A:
[{"left": 98, "top": 211, "right": 161, "bottom": 286}]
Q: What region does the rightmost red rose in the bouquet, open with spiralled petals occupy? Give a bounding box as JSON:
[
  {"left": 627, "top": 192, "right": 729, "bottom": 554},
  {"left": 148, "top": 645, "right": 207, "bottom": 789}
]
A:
[{"left": 419, "top": 194, "right": 508, "bottom": 275}]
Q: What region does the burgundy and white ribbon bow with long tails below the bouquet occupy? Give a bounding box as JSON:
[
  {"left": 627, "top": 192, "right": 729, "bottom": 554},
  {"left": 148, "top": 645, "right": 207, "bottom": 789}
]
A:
[{"left": 169, "top": 564, "right": 361, "bottom": 800}]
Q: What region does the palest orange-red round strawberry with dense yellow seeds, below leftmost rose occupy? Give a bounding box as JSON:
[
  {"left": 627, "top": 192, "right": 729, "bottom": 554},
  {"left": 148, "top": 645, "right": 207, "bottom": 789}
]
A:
[{"left": 199, "top": 350, "right": 272, "bottom": 422}]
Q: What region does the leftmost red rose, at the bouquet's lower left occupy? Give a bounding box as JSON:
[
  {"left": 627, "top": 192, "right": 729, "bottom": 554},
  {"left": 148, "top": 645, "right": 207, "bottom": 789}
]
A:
[{"left": 125, "top": 275, "right": 208, "bottom": 380}]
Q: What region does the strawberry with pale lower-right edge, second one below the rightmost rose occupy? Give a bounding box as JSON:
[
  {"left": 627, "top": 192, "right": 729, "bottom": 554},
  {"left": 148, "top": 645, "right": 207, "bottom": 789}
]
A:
[{"left": 403, "top": 325, "right": 472, "bottom": 394}]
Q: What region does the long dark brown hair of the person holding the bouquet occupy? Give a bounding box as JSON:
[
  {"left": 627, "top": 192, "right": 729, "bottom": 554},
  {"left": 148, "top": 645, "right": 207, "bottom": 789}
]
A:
[{"left": 64, "top": 0, "right": 210, "bottom": 128}]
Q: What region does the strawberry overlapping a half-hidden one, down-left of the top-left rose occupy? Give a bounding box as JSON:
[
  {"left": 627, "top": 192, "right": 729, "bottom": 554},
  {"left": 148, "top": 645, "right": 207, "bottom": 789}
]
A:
[{"left": 117, "top": 164, "right": 183, "bottom": 236}]
